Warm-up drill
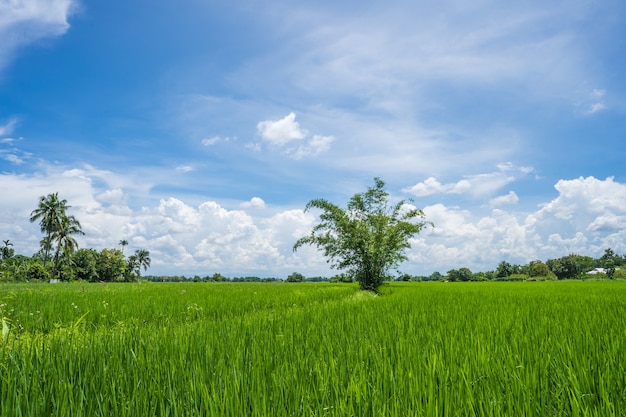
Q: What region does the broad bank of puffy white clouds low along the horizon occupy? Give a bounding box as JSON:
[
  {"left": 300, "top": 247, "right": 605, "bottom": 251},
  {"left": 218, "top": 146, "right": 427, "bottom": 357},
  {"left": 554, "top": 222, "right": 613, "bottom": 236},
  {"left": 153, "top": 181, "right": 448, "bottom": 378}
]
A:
[{"left": 0, "top": 163, "right": 626, "bottom": 277}]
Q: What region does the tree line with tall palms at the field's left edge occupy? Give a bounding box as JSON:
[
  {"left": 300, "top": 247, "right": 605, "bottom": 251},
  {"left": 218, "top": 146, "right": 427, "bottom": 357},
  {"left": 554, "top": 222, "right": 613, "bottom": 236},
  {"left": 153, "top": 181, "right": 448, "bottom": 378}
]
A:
[{"left": 0, "top": 193, "right": 151, "bottom": 282}]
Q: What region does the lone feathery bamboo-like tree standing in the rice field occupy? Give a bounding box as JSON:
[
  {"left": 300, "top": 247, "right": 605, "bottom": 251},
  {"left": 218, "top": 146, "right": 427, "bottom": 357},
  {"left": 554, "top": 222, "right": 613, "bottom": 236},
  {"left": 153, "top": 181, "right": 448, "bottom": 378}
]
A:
[{"left": 293, "top": 178, "right": 431, "bottom": 292}]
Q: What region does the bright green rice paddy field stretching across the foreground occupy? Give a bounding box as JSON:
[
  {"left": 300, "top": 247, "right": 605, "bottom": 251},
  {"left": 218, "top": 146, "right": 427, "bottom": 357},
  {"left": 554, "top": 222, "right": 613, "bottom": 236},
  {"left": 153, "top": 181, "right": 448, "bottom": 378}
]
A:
[{"left": 0, "top": 281, "right": 626, "bottom": 417}]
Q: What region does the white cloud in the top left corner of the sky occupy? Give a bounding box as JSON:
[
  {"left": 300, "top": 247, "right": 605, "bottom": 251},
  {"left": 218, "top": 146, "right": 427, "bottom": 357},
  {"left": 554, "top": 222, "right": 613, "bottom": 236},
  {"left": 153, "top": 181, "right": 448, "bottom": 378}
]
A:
[{"left": 0, "top": 0, "right": 76, "bottom": 69}]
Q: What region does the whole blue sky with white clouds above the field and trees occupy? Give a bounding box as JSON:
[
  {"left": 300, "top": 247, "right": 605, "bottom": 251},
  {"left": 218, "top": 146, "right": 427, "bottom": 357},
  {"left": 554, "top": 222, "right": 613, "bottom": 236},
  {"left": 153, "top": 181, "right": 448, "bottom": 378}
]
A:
[{"left": 0, "top": 0, "right": 626, "bottom": 278}]
